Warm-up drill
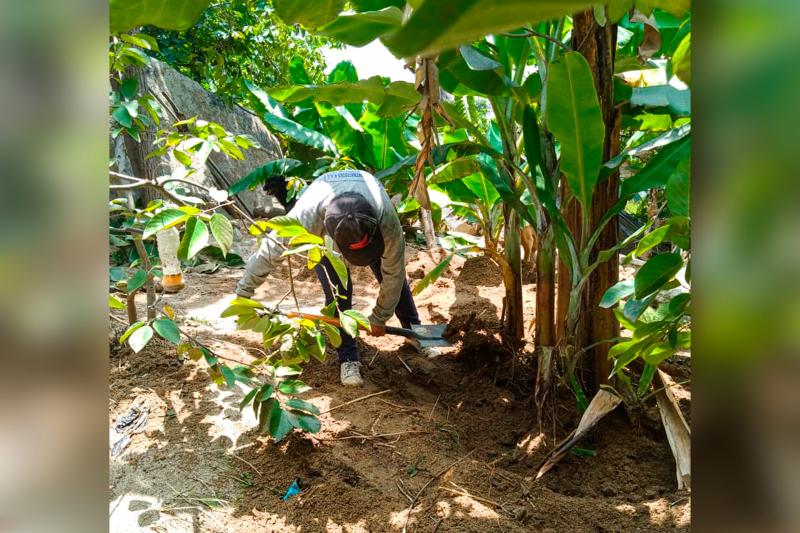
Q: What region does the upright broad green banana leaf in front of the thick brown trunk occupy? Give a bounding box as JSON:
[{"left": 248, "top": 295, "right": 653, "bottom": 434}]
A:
[{"left": 546, "top": 52, "right": 605, "bottom": 210}]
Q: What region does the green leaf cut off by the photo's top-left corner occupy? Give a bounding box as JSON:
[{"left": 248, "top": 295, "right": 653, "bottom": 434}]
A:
[{"left": 109, "top": 0, "right": 210, "bottom": 33}]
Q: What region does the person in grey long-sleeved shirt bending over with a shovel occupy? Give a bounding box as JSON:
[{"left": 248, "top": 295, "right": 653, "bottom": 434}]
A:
[{"left": 236, "top": 170, "right": 439, "bottom": 386}]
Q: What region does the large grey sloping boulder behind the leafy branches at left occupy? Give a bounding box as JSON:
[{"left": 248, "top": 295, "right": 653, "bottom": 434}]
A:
[{"left": 113, "top": 59, "right": 284, "bottom": 218}]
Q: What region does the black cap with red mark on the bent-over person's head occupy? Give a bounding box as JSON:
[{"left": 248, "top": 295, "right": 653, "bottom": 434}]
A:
[{"left": 325, "top": 192, "right": 383, "bottom": 266}]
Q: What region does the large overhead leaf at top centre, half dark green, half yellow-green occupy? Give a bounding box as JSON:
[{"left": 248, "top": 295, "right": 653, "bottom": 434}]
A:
[{"left": 383, "top": 0, "right": 594, "bottom": 57}]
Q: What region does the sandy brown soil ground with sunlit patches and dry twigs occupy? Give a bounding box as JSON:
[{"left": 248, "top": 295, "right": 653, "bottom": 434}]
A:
[{"left": 109, "top": 243, "right": 690, "bottom": 532}]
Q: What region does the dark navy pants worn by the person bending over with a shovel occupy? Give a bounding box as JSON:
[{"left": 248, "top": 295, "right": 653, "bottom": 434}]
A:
[{"left": 314, "top": 257, "right": 420, "bottom": 363}]
